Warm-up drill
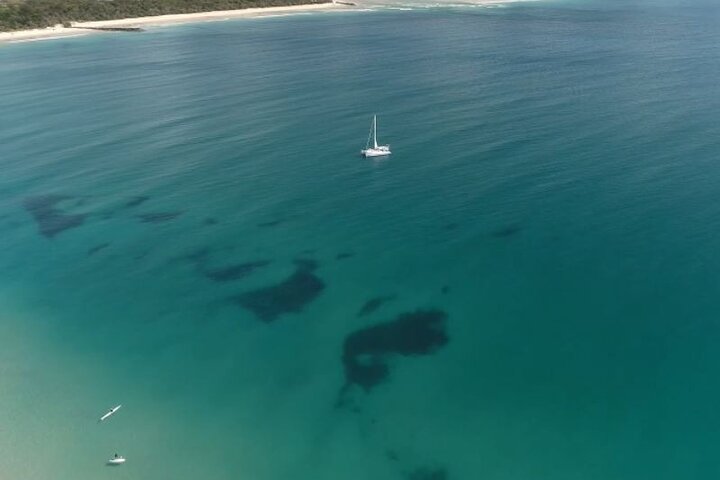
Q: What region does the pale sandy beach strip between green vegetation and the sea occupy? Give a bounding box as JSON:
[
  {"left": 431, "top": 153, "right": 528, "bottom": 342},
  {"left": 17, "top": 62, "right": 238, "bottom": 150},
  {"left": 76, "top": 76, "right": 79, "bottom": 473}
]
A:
[{"left": 0, "top": 3, "right": 348, "bottom": 45}]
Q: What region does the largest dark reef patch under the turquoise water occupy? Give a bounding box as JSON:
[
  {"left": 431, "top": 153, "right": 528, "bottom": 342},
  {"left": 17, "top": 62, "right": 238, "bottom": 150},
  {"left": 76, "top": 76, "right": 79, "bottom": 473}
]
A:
[{"left": 341, "top": 309, "right": 448, "bottom": 397}]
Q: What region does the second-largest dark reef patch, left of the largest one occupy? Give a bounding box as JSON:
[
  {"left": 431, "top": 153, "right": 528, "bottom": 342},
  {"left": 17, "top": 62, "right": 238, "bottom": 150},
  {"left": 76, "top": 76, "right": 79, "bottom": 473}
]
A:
[{"left": 234, "top": 259, "right": 325, "bottom": 323}]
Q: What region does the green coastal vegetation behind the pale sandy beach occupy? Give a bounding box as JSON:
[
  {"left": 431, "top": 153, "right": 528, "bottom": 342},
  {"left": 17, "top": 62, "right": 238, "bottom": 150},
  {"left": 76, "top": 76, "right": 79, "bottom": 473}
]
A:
[{"left": 0, "top": 0, "right": 328, "bottom": 31}]
